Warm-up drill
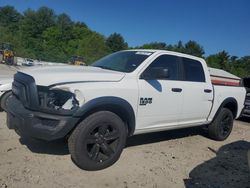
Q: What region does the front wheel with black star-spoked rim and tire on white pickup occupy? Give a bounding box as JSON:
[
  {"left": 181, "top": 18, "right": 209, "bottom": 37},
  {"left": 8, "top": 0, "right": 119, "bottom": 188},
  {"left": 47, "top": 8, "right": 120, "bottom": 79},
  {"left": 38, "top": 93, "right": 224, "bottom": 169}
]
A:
[{"left": 68, "top": 111, "right": 127, "bottom": 171}]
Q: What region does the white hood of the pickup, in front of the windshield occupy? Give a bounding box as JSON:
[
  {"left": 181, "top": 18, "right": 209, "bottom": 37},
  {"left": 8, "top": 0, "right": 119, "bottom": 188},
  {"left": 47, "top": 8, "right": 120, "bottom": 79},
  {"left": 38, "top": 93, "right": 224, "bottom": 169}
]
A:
[{"left": 19, "top": 65, "right": 125, "bottom": 86}]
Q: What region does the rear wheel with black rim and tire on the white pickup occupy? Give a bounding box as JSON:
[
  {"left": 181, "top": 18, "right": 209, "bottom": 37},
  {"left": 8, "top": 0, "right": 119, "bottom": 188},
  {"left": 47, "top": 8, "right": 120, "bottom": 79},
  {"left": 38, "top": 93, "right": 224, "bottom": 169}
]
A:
[{"left": 208, "top": 108, "right": 234, "bottom": 141}]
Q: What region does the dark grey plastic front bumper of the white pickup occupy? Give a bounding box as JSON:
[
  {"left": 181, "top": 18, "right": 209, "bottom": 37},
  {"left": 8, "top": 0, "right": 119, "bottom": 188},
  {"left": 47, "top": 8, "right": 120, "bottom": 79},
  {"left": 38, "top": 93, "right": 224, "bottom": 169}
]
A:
[{"left": 4, "top": 95, "right": 79, "bottom": 141}]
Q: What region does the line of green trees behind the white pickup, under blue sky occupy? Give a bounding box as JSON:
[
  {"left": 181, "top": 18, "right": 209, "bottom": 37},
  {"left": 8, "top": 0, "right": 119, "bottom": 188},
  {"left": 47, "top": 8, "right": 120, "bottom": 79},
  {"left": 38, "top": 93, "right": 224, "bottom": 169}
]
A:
[{"left": 0, "top": 6, "right": 250, "bottom": 77}]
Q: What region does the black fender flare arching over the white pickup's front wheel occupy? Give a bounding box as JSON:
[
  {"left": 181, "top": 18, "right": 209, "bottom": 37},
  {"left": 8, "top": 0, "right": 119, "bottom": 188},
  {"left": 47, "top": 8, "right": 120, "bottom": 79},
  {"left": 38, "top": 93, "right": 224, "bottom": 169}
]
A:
[{"left": 74, "top": 96, "right": 135, "bottom": 136}]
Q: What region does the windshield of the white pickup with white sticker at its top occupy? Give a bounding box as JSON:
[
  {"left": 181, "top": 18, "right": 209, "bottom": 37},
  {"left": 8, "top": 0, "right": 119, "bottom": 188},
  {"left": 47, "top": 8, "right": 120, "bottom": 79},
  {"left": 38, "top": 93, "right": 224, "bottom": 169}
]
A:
[{"left": 91, "top": 51, "right": 152, "bottom": 72}]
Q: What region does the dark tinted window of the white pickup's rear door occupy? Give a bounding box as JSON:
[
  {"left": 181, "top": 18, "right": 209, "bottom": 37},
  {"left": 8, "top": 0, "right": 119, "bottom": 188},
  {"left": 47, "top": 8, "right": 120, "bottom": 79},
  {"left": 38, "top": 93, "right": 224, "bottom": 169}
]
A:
[{"left": 182, "top": 57, "right": 205, "bottom": 82}]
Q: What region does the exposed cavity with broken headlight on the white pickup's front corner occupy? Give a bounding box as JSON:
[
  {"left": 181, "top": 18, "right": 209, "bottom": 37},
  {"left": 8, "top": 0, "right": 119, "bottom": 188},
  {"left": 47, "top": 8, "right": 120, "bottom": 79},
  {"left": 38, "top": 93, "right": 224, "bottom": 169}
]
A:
[{"left": 38, "top": 86, "right": 84, "bottom": 111}]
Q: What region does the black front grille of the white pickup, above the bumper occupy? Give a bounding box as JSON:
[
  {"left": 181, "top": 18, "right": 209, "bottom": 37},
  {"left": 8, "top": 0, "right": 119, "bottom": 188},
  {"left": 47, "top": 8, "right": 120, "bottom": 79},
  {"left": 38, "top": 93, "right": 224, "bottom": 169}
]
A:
[{"left": 12, "top": 72, "right": 38, "bottom": 109}]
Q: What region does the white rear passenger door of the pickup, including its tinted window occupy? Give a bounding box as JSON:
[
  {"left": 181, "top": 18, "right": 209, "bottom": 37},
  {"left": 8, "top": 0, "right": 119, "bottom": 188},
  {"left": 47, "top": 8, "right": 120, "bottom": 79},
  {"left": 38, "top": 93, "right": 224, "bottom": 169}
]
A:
[{"left": 180, "top": 57, "right": 213, "bottom": 124}]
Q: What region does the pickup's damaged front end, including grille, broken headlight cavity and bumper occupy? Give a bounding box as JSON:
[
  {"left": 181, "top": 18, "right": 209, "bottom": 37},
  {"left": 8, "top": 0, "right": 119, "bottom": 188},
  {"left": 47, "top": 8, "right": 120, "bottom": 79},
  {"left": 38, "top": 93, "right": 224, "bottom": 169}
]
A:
[{"left": 5, "top": 72, "right": 84, "bottom": 141}]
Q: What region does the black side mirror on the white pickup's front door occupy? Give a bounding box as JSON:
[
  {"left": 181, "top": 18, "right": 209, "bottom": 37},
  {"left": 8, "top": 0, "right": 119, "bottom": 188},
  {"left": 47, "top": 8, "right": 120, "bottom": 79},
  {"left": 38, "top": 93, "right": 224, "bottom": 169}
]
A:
[{"left": 140, "top": 67, "right": 170, "bottom": 80}]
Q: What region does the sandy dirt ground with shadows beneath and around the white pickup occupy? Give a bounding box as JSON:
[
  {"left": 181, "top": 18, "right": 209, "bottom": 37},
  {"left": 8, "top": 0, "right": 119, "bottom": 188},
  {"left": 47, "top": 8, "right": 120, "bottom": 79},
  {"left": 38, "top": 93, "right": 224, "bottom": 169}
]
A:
[{"left": 0, "top": 112, "right": 250, "bottom": 188}]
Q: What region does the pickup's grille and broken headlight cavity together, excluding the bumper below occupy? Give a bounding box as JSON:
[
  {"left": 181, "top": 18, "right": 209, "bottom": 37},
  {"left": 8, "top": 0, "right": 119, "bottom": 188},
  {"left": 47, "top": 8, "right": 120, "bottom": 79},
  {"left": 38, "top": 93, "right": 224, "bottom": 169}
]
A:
[{"left": 12, "top": 73, "right": 84, "bottom": 115}]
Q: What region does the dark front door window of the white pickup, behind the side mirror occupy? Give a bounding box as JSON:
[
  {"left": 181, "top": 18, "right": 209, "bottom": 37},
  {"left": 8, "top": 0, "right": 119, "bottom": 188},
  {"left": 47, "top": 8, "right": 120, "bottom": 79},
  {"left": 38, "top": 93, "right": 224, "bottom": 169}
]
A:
[{"left": 144, "top": 55, "right": 179, "bottom": 80}]
